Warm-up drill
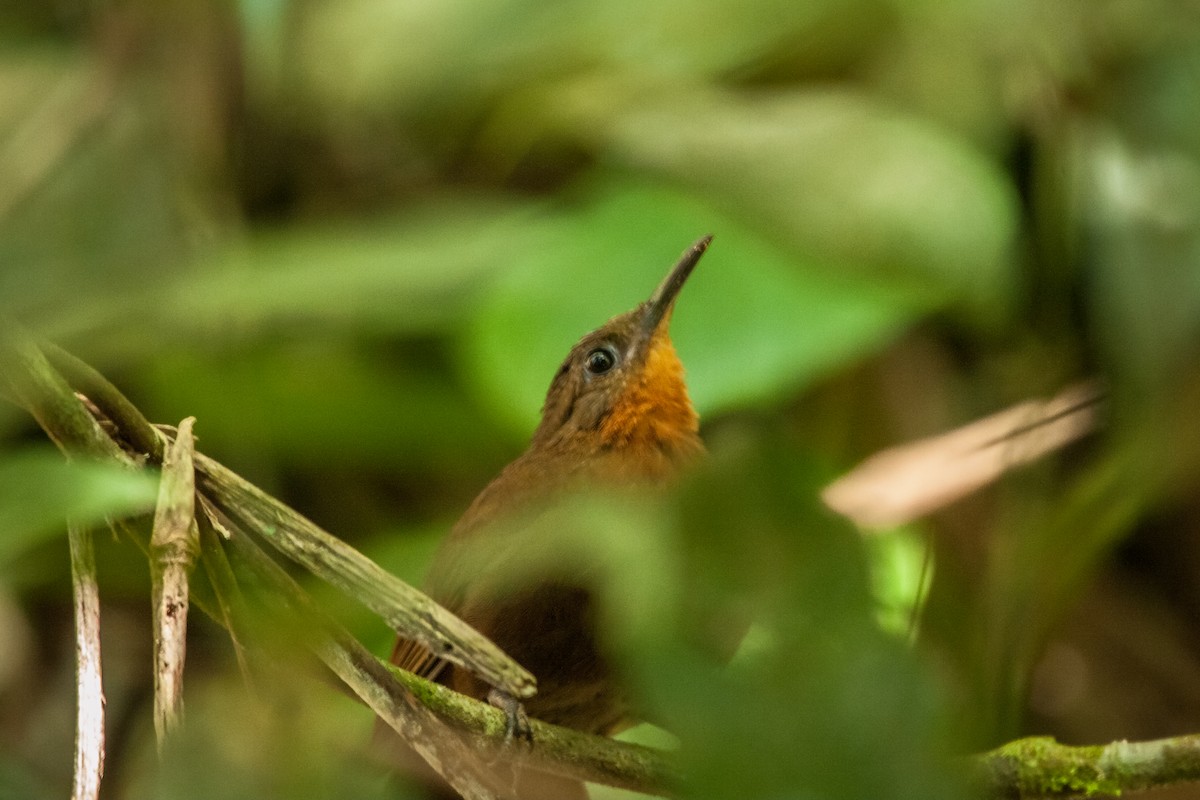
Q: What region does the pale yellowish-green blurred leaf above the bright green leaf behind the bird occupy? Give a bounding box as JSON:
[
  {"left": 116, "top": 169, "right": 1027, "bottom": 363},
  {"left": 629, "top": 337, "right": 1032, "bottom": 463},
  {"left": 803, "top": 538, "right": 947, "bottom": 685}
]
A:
[{"left": 597, "top": 91, "right": 1018, "bottom": 319}]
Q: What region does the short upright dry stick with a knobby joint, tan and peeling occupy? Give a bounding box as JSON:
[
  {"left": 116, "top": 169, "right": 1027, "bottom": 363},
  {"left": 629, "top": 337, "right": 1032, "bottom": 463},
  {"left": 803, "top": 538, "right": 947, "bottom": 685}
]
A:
[{"left": 150, "top": 416, "right": 200, "bottom": 752}]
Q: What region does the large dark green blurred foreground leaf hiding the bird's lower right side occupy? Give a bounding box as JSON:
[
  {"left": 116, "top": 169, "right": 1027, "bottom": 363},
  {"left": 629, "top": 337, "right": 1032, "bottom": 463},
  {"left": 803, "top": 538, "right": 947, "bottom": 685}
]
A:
[{"left": 652, "top": 434, "right": 959, "bottom": 798}]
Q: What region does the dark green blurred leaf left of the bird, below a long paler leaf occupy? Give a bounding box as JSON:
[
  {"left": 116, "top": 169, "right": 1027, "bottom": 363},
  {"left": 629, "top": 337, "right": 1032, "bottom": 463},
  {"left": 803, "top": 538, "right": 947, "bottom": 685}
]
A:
[{"left": 133, "top": 342, "right": 505, "bottom": 474}]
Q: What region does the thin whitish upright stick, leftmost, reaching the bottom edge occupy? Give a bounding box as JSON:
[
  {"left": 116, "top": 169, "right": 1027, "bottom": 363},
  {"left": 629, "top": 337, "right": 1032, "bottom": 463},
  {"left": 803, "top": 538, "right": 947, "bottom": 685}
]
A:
[{"left": 67, "top": 524, "right": 104, "bottom": 800}]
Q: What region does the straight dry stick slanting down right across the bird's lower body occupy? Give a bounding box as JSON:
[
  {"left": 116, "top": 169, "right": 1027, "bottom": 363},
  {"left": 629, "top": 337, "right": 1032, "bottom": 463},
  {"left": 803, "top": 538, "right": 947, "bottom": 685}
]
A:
[{"left": 196, "top": 453, "right": 536, "bottom": 697}]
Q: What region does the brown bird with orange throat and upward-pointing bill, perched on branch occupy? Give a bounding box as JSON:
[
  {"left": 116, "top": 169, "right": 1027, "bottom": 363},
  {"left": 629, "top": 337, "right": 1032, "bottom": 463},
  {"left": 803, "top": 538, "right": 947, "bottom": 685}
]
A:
[{"left": 392, "top": 236, "right": 712, "bottom": 791}]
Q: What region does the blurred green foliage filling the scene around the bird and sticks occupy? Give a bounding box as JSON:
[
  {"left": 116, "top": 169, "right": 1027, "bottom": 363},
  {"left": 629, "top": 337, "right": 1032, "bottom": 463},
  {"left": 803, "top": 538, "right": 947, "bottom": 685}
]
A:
[{"left": 0, "top": 0, "right": 1200, "bottom": 798}]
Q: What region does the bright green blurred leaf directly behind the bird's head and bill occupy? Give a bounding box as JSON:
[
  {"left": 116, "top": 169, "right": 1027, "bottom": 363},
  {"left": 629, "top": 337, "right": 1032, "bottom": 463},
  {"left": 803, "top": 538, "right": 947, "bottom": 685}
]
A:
[{"left": 466, "top": 180, "right": 937, "bottom": 429}]
